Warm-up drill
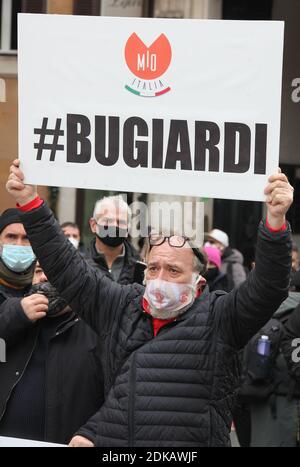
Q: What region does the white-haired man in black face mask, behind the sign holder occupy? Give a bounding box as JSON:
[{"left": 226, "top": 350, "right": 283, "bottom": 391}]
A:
[{"left": 86, "top": 196, "right": 139, "bottom": 284}]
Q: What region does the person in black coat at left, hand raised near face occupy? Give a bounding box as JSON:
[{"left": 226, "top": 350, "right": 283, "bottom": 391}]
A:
[{"left": 0, "top": 264, "right": 103, "bottom": 444}]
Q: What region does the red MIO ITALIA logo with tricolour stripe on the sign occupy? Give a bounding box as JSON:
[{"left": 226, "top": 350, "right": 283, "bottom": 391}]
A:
[{"left": 125, "top": 32, "right": 172, "bottom": 97}]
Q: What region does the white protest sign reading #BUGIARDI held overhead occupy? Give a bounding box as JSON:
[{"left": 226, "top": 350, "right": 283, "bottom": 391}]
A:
[{"left": 19, "top": 15, "right": 283, "bottom": 200}]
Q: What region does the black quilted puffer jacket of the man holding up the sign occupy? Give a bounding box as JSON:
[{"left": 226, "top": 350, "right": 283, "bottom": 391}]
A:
[{"left": 21, "top": 205, "right": 291, "bottom": 447}]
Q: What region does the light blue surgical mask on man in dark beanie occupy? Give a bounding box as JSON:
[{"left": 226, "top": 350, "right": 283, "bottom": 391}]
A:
[{"left": 1, "top": 245, "right": 35, "bottom": 272}]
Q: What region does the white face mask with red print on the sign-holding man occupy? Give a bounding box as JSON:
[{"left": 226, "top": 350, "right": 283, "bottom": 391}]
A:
[{"left": 144, "top": 274, "right": 201, "bottom": 319}]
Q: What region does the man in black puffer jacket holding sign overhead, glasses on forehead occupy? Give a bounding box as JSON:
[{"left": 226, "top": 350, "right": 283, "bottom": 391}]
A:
[{"left": 7, "top": 160, "right": 293, "bottom": 448}]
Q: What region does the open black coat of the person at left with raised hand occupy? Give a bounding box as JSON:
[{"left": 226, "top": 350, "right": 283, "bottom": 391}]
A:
[{"left": 0, "top": 298, "right": 103, "bottom": 444}]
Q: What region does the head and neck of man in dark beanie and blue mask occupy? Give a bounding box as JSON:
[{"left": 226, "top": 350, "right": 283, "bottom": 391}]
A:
[{"left": 0, "top": 209, "right": 35, "bottom": 305}]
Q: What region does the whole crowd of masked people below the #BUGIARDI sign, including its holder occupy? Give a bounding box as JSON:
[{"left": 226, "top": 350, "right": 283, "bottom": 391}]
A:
[{"left": 0, "top": 161, "right": 300, "bottom": 447}]
